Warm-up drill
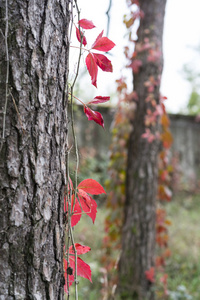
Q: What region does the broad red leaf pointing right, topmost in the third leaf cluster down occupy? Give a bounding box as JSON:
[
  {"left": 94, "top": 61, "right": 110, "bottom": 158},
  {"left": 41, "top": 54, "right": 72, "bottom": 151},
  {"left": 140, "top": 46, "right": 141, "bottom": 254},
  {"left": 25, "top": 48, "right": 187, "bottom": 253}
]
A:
[{"left": 77, "top": 178, "right": 106, "bottom": 195}]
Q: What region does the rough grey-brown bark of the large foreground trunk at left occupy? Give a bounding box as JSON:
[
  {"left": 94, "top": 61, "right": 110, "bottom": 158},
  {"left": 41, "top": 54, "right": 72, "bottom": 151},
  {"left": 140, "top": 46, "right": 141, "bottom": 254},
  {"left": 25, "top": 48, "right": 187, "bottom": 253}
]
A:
[{"left": 0, "top": 0, "right": 69, "bottom": 300}]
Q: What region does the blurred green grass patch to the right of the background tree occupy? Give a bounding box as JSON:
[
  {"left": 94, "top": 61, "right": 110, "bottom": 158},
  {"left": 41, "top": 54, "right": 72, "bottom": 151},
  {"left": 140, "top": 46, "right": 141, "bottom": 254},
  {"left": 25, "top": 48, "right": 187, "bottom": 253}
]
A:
[{"left": 166, "top": 194, "right": 200, "bottom": 300}]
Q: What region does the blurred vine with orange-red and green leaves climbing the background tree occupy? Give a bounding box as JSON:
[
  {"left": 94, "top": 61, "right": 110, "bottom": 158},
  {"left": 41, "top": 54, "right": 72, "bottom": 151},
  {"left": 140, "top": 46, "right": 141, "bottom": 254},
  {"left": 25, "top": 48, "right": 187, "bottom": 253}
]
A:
[{"left": 102, "top": 0, "right": 173, "bottom": 299}]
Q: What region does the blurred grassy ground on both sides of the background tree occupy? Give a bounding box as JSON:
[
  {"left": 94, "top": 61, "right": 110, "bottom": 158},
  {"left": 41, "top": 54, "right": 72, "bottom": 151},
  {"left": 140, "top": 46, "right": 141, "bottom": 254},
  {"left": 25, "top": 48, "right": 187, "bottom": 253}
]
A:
[{"left": 67, "top": 193, "right": 200, "bottom": 300}]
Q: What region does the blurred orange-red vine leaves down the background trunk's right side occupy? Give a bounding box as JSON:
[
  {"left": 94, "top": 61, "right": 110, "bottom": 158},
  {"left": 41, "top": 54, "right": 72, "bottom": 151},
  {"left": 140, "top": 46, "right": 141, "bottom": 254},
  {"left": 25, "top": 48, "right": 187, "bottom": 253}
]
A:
[{"left": 142, "top": 99, "right": 173, "bottom": 294}]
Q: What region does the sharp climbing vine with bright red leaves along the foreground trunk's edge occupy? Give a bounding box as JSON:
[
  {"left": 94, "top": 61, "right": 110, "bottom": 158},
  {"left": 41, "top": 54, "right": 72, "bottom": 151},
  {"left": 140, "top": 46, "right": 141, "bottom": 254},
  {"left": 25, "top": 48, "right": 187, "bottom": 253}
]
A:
[{"left": 63, "top": 0, "right": 115, "bottom": 299}]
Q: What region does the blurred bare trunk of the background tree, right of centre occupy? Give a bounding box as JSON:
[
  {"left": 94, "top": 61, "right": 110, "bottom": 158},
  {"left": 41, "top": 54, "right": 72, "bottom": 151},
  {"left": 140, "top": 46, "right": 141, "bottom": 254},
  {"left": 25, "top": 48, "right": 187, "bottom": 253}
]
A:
[{"left": 118, "top": 0, "right": 166, "bottom": 300}]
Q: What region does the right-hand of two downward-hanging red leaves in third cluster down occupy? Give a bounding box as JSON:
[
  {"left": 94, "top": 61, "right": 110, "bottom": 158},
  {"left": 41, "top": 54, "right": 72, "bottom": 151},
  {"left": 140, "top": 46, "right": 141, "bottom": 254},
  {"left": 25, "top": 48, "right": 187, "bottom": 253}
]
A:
[{"left": 78, "top": 189, "right": 97, "bottom": 223}]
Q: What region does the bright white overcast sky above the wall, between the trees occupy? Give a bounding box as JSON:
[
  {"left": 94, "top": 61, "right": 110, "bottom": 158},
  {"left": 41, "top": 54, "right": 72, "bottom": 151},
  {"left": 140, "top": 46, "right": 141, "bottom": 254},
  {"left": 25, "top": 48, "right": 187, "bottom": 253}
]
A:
[{"left": 71, "top": 0, "right": 200, "bottom": 113}]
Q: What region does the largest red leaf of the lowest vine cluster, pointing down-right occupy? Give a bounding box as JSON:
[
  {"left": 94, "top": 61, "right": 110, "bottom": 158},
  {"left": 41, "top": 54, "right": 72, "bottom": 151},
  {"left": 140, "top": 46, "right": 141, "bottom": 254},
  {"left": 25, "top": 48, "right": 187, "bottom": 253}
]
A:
[{"left": 69, "top": 256, "right": 92, "bottom": 282}]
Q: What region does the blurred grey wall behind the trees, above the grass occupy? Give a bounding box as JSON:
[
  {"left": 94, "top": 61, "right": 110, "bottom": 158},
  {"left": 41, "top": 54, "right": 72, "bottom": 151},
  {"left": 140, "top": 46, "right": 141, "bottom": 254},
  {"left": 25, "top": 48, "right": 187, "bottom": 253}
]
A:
[{"left": 72, "top": 107, "right": 200, "bottom": 185}]
